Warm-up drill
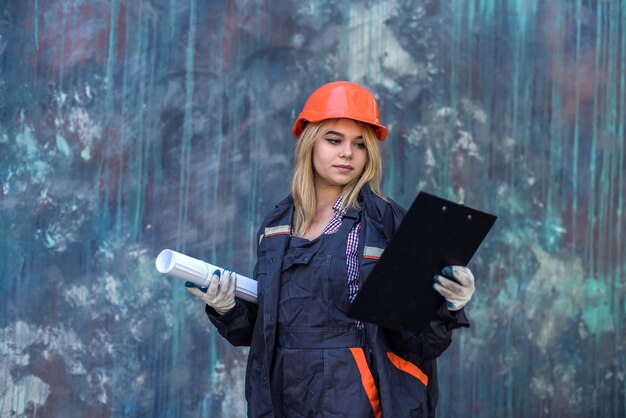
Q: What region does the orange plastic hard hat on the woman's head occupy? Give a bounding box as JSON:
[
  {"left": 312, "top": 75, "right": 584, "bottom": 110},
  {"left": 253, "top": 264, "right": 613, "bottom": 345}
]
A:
[{"left": 291, "top": 81, "right": 387, "bottom": 141}]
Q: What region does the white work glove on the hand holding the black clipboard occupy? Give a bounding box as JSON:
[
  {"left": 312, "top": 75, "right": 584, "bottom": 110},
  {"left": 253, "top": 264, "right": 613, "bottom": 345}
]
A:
[{"left": 433, "top": 266, "right": 475, "bottom": 311}]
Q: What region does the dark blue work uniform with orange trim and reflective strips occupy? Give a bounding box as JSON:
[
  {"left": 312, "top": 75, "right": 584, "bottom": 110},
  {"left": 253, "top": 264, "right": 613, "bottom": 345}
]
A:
[{"left": 206, "top": 185, "right": 469, "bottom": 418}]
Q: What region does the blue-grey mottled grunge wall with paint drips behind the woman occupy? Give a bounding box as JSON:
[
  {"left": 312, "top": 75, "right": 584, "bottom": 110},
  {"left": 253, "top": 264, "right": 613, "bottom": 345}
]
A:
[{"left": 0, "top": 0, "right": 626, "bottom": 418}]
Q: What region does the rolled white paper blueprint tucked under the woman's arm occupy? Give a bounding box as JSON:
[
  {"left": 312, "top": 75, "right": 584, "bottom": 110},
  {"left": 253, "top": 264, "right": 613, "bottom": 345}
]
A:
[{"left": 156, "top": 250, "right": 256, "bottom": 303}]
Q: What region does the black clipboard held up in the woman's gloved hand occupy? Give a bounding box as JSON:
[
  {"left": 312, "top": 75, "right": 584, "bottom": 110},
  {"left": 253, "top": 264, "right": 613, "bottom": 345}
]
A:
[{"left": 348, "top": 192, "right": 497, "bottom": 332}]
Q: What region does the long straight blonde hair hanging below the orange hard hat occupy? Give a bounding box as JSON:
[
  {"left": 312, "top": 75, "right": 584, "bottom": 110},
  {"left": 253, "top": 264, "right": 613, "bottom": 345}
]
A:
[{"left": 291, "top": 119, "right": 386, "bottom": 236}]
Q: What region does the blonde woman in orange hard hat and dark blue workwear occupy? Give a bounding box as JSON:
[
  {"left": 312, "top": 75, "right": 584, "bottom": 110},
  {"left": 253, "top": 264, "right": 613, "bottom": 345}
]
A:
[{"left": 189, "top": 81, "right": 474, "bottom": 418}]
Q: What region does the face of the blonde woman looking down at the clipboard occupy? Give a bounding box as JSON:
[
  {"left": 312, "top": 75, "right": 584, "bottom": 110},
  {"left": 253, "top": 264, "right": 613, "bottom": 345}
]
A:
[{"left": 313, "top": 119, "right": 367, "bottom": 188}]
